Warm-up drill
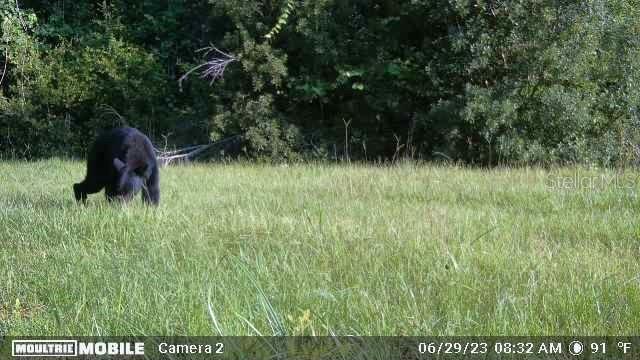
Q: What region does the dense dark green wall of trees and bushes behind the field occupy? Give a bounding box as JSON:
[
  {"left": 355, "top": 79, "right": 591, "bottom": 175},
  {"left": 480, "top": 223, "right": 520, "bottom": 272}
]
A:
[{"left": 0, "top": 0, "right": 640, "bottom": 165}]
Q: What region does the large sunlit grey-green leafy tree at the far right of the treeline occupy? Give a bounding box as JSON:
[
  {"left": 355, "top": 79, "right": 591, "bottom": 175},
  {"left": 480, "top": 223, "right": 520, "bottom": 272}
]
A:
[{"left": 456, "top": 0, "right": 640, "bottom": 165}]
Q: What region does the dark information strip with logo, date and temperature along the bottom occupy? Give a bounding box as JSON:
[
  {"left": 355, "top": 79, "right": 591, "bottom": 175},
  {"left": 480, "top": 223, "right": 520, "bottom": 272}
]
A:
[{"left": 0, "top": 336, "right": 640, "bottom": 360}]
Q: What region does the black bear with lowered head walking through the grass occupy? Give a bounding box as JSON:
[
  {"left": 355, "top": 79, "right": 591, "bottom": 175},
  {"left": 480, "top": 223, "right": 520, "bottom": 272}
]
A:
[{"left": 73, "top": 127, "right": 160, "bottom": 205}]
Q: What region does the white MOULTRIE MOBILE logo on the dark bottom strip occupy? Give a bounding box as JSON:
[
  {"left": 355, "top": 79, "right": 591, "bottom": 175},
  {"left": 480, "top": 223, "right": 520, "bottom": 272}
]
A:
[{"left": 11, "top": 340, "right": 144, "bottom": 357}]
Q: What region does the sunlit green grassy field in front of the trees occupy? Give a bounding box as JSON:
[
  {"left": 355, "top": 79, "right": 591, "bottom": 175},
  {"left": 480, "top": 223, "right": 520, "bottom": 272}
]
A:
[{"left": 0, "top": 160, "right": 640, "bottom": 335}]
